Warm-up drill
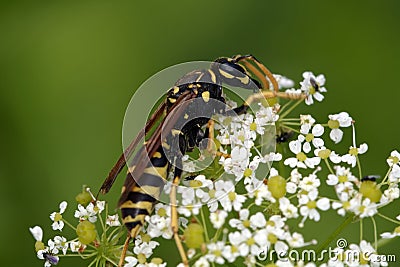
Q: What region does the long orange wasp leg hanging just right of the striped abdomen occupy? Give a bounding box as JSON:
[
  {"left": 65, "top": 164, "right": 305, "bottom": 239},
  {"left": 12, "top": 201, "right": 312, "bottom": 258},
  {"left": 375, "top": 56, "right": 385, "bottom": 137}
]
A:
[{"left": 170, "top": 168, "right": 189, "bottom": 266}]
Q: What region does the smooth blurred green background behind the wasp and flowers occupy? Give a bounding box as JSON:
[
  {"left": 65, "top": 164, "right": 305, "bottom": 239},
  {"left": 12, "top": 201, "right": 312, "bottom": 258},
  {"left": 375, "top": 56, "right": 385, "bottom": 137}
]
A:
[{"left": 0, "top": 0, "right": 400, "bottom": 266}]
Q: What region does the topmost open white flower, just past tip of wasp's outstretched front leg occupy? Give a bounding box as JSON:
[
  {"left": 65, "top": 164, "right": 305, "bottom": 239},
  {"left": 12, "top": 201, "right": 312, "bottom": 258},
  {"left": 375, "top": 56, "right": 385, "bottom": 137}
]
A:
[{"left": 300, "top": 71, "right": 326, "bottom": 105}]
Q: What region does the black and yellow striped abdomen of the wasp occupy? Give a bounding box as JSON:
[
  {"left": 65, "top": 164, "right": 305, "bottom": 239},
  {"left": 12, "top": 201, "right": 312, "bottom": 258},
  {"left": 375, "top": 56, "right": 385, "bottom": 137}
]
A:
[{"left": 120, "top": 146, "right": 169, "bottom": 237}]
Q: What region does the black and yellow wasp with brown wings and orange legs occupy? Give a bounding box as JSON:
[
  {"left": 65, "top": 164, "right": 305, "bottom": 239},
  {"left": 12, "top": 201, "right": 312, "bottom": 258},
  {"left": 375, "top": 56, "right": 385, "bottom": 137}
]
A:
[{"left": 100, "top": 55, "right": 304, "bottom": 266}]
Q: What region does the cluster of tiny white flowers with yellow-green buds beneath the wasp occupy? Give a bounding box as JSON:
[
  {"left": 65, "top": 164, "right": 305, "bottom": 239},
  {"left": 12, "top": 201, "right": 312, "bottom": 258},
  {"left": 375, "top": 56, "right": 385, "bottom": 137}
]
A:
[{"left": 30, "top": 72, "right": 400, "bottom": 267}]
